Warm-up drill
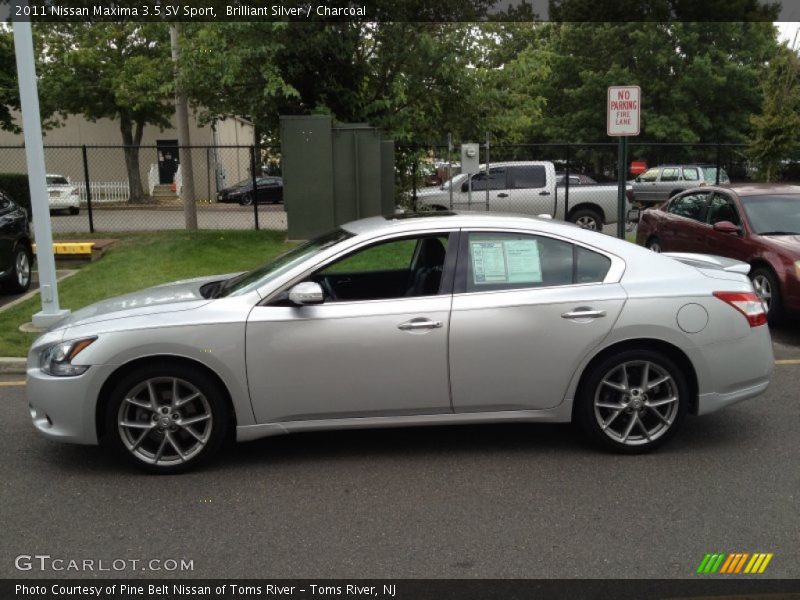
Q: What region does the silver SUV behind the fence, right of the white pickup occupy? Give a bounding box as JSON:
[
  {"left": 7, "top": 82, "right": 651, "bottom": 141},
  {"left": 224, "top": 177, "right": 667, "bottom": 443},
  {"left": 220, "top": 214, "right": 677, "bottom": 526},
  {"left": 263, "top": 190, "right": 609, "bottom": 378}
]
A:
[{"left": 633, "top": 164, "right": 731, "bottom": 206}]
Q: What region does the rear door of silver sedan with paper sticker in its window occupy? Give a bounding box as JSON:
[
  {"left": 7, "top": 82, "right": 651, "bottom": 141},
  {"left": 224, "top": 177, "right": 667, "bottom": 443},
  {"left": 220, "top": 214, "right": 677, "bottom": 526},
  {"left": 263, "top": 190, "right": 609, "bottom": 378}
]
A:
[{"left": 450, "top": 230, "right": 626, "bottom": 413}]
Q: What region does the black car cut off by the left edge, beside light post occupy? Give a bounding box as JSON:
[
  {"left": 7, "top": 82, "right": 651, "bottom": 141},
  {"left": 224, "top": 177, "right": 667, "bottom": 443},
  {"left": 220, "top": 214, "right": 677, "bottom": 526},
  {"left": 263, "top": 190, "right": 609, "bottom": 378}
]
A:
[{"left": 0, "top": 191, "right": 33, "bottom": 294}]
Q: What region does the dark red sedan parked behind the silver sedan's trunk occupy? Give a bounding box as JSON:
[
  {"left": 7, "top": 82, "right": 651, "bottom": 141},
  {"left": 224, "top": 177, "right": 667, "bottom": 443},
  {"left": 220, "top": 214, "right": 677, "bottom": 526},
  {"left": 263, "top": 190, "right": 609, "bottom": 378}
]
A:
[{"left": 636, "top": 184, "right": 800, "bottom": 322}]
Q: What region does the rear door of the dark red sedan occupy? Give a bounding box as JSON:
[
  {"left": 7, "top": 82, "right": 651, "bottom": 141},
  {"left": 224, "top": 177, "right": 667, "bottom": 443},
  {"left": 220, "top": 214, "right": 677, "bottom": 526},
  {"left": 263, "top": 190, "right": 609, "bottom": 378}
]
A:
[{"left": 659, "top": 192, "right": 710, "bottom": 252}]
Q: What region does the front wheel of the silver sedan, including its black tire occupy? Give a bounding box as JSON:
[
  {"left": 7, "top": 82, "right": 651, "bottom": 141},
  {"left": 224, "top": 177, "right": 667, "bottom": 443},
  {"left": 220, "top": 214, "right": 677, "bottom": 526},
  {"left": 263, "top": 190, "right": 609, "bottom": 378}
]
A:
[{"left": 101, "top": 362, "right": 231, "bottom": 474}]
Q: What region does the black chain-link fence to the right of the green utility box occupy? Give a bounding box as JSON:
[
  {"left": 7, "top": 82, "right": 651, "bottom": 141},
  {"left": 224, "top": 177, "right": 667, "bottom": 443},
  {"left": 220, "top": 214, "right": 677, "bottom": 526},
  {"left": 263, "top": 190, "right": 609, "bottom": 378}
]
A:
[{"left": 397, "top": 140, "right": 800, "bottom": 228}]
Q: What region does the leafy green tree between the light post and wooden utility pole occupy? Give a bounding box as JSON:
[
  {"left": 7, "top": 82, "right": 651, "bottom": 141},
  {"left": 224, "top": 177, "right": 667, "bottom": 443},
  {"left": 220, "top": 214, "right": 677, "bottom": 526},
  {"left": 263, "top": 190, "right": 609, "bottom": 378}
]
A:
[{"left": 37, "top": 22, "right": 174, "bottom": 202}]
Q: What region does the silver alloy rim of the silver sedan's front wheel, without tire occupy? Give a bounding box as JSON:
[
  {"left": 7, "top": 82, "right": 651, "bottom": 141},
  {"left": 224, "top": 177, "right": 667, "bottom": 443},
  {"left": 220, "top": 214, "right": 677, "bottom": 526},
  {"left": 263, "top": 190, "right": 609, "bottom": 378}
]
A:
[{"left": 117, "top": 377, "right": 214, "bottom": 467}]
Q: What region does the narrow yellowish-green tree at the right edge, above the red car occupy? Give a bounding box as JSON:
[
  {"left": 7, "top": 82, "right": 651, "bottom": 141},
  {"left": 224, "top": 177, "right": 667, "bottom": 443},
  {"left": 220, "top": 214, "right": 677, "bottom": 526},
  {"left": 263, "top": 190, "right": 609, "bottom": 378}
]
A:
[{"left": 750, "top": 46, "right": 800, "bottom": 182}]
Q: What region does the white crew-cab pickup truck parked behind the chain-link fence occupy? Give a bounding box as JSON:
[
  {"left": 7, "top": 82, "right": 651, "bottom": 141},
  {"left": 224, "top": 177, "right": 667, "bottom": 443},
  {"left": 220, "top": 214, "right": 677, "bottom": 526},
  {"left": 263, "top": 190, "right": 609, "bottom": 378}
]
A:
[{"left": 417, "top": 161, "right": 633, "bottom": 231}]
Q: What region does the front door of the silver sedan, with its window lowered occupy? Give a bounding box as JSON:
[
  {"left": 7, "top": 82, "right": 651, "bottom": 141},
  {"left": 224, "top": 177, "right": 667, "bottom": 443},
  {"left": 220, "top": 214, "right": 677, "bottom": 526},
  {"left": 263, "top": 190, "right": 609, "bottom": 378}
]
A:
[{"left": 246, "top": 231, "right": 457, "bottom": 423}]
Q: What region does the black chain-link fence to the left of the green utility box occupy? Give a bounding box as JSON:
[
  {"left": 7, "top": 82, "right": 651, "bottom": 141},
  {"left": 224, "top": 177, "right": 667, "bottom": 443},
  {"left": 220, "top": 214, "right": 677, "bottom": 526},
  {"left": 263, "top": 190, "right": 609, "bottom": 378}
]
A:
[{"left": 0, "top": 143, "right": 286, "bottom": 233}]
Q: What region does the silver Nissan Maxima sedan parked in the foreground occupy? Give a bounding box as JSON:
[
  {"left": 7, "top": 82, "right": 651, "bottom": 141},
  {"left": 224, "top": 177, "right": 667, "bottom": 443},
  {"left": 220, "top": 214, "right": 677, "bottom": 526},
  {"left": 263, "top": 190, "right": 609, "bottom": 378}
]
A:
[{"left": 26, "top": 212, "right": 773, "bottom": 472}]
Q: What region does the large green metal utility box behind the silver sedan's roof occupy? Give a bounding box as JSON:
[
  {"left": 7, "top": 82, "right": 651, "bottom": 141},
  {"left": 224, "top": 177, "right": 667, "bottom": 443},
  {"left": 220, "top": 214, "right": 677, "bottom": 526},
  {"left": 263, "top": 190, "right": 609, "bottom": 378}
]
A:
[{"left": 281, "top": 115, "right": 394, "bottom": 239}]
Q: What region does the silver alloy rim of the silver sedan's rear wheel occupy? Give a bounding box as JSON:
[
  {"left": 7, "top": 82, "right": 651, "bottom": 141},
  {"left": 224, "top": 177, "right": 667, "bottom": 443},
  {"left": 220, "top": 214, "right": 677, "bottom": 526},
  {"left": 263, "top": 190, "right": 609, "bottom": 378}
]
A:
[{"left": 594, "top": 360, "right": 680, "bottom": 446}]
